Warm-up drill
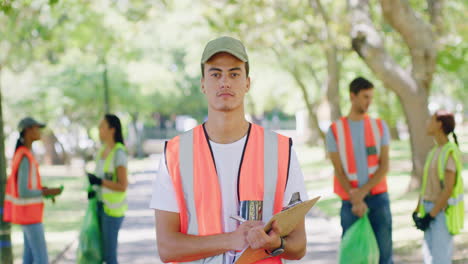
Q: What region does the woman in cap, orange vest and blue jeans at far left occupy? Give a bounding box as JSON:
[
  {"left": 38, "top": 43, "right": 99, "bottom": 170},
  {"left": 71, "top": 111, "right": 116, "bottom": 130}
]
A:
[{"left": 3, "top": 117, "right": 62, "bottom": 264}]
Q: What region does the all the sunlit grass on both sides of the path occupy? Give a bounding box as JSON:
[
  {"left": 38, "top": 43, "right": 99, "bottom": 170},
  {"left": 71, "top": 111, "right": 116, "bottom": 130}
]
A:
[{"left": 12, "top": 124, "right": 468, "bottom": 263}]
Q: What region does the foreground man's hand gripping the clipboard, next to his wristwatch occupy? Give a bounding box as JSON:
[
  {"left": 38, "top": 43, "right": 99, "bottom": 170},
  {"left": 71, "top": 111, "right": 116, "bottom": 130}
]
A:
[{"left": 247, "top": 221, "right": 281, "bottom": 252}]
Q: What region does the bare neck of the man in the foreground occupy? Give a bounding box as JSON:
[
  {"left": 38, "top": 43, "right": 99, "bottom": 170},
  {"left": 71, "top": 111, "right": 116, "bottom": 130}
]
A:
[{"left": 205, "top": 110, "right": 249, "bottom": 144}]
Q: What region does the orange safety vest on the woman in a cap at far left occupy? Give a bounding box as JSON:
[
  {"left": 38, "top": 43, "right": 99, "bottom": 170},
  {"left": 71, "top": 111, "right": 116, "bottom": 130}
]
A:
[{"left": 3, "top": 146, "right": 44, "bottom": 225}]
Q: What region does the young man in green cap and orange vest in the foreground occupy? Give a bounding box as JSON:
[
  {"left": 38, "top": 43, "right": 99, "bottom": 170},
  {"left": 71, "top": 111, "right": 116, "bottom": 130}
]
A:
[{"left": 150, "top": 37, "right": 307, "bottom": 264}]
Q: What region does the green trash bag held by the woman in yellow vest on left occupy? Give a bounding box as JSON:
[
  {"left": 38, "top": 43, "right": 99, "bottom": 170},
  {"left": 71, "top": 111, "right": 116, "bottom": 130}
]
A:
[{"left": 76, "top": 189, "right": 102, "bottom": 264}]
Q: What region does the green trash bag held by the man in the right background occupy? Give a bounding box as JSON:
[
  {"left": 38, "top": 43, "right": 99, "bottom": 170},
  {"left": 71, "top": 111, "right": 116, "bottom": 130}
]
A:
[{"left": 339, "top": 213, "right": 380, "bottom": 264}]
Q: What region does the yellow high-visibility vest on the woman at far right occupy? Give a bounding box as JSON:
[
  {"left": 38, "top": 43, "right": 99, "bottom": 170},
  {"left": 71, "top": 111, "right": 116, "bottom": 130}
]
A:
[{"left": 418, "top": 142, "right": 465, "bottom": 235}]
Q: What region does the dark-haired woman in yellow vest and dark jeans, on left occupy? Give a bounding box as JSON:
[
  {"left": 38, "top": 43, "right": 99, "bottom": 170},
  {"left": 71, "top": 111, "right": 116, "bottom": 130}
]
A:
[{"left": 88, "top": 114, "right": 128, "bottom": 264}]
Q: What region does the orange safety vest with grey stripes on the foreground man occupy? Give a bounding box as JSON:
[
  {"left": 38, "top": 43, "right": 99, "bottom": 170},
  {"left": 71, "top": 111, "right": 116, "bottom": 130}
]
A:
[{"left": 165, "top": 124, "right": 292, "bottom": 264}]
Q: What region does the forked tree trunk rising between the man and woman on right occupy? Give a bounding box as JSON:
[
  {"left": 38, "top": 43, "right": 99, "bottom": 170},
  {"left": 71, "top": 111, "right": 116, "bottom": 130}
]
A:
[{"left": 348, "top": 0, "right": 436, "bottom": 189}]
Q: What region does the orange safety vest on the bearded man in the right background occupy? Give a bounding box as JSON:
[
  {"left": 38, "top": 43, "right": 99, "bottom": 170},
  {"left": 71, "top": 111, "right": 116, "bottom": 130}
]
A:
[{"left": 331, "top": 115, "right": 387, "bottom": 200}]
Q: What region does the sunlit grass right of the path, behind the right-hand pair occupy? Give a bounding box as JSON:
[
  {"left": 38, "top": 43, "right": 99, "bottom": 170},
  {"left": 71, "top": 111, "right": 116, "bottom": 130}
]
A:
[{"left": 302, "top": 126, "right": 468, "bottom": 263}]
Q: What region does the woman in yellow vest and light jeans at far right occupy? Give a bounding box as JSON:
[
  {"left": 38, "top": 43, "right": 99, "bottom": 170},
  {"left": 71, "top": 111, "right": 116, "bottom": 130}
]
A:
[{"left": 413, "top": 110, "right": 464, "bottom": 264}]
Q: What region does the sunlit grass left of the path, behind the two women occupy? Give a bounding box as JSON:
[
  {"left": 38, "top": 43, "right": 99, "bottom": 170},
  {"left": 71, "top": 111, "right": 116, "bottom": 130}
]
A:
[{"left": 12, "top": 159, "right": 155, "bottom": 264}]
